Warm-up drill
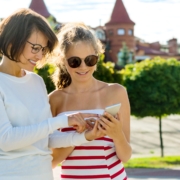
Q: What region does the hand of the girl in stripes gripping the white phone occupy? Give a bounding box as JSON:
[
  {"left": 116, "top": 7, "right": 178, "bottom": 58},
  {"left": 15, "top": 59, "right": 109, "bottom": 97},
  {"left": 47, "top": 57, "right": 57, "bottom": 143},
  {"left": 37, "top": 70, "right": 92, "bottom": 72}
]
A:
[{"left": 98, "top": 112, "right": 122, "bottom": 139}]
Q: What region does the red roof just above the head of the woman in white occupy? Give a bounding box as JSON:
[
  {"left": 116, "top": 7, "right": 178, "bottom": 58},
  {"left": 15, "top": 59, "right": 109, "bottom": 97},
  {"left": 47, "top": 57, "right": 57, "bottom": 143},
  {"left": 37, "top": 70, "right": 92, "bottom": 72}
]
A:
[{"left": 29, "top": 0, "right": 51, "bottom": 18}]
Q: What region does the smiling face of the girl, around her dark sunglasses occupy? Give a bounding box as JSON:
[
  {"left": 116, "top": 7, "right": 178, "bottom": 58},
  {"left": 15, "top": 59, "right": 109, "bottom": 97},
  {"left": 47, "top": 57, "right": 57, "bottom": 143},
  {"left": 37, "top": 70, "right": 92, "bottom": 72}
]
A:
[{"left": 64, "top": 42, "right": 96, "bottom": 82}]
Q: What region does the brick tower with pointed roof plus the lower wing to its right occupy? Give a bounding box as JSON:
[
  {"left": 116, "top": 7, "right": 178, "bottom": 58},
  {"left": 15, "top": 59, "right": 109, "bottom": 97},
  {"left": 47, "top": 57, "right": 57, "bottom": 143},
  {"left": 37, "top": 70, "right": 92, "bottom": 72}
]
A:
[{"left": 102, "top": 0, "right": 180, "bottom": 63}]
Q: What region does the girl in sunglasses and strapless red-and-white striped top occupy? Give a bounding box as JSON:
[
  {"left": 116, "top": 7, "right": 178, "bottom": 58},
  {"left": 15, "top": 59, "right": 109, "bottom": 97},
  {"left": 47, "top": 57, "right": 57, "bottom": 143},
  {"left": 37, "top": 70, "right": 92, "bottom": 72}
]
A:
[{"left": 49, "top": 23, "right": 132, "bottom": 180}]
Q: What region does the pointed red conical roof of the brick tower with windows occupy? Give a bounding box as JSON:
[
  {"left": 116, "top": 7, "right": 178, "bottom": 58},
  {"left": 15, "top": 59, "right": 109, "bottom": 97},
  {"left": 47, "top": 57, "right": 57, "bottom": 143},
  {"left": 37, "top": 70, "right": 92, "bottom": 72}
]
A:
[{"left": 106, "top": 0, "right": 135, "bottom": 25}]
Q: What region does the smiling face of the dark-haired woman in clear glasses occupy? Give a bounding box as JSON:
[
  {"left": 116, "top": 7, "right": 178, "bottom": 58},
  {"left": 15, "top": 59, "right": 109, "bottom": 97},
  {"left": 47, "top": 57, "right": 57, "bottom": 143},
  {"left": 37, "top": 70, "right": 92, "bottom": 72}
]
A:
[{"left": 17, "top": 31, "right": 48, "bottom": 71}]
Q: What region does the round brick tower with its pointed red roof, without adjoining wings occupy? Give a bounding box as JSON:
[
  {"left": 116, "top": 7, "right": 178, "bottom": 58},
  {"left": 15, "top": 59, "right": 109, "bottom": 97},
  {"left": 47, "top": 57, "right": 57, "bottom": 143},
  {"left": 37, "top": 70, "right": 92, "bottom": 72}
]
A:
[{"left": 105, "top": 0, "right": 136, "bottom": 62}]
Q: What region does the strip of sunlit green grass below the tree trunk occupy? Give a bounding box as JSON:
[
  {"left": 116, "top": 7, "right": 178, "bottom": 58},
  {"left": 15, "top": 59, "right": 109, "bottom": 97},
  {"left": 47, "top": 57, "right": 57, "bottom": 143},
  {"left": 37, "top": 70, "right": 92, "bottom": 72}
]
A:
[{"left": 124, "top": 156, "right": 180, "bottom": 168}]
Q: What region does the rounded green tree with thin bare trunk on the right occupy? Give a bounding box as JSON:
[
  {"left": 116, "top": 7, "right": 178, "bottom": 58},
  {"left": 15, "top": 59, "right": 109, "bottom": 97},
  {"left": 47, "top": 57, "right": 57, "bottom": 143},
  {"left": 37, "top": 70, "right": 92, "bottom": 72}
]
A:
[{"left": 121, "top": 57, "right": 180, "bottom": 157}]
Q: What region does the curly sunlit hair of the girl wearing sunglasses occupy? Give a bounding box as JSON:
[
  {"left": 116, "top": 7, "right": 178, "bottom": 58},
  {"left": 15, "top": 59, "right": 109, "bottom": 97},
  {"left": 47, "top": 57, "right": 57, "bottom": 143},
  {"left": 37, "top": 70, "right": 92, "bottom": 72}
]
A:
[{"left": 52, "top": 23, "right": 104, "bottom": 89}]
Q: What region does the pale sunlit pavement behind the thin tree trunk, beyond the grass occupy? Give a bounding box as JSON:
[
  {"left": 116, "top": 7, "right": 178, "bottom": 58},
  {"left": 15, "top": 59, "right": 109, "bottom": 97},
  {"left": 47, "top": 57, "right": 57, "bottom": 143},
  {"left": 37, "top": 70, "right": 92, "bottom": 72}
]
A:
[{"left": 131, "top": 115, "right": 180, "bottom": 158}]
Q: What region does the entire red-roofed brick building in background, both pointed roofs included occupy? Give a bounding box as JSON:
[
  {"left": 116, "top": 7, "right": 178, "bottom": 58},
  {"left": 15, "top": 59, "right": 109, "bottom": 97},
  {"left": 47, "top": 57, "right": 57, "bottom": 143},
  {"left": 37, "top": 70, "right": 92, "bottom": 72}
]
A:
[{"left": 1, "top": 0, "right": 180, "bottom": 64}]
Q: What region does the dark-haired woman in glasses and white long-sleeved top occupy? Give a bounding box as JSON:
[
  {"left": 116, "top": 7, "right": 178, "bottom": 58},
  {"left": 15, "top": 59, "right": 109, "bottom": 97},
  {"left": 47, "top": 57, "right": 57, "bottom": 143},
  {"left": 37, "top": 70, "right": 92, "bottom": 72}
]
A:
[{"left": 0, "top": 9, "right": 101, "bottom": 180}]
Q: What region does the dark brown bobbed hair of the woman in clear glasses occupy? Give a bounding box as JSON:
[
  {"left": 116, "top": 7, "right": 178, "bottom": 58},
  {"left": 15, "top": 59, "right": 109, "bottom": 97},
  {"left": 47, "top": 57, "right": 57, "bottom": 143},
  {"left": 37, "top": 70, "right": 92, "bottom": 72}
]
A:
[{"left": 0, "top": 8, "right": 58, "bottom": 67}]
